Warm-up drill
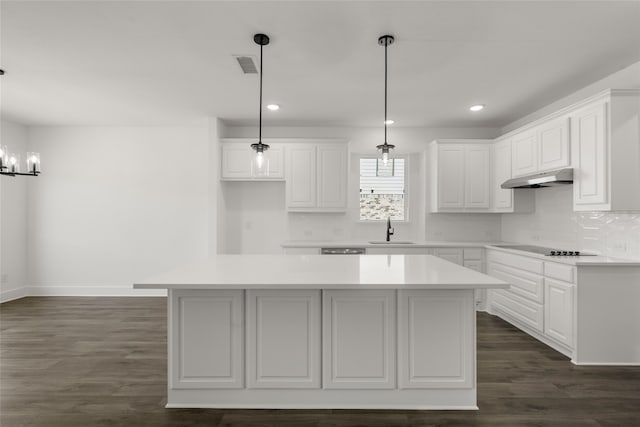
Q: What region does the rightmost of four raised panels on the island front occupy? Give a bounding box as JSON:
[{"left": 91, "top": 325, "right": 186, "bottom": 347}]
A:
[{"left": 398, "top": 289, "right": 475, "bottom": 389}]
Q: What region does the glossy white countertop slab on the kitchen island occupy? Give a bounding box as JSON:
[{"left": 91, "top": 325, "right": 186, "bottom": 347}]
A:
[{"left": 133, "top": 255, "right": 509, "bottom": 289}]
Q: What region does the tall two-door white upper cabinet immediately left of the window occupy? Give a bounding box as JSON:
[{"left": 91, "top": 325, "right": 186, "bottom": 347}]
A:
[{"left": 286, "top": 142, "right": 347, "bottom": 212}]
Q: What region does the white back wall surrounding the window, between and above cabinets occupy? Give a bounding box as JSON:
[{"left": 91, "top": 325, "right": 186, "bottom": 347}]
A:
[{"left": 220, "top": 126, "right": 500, "bottom": 253}]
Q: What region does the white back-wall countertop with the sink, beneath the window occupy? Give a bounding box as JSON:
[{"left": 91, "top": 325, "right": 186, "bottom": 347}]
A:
[{"left": 280, "top": 238, "right": 503, "bottom": 248}]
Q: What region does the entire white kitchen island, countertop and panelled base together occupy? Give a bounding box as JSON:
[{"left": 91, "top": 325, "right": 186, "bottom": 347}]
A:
[{"left": 134, "top": 255, "right": 508, "bottom": 409}]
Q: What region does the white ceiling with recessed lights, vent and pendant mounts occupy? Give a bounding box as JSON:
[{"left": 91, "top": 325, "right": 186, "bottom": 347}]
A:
[{"left": 0, "top": 0, "right": 640, "bottom": 127}]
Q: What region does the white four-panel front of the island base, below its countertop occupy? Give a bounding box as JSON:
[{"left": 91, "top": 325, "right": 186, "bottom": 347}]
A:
[{"left": 167, "top": 289, "right": 477, "bottom": 410}]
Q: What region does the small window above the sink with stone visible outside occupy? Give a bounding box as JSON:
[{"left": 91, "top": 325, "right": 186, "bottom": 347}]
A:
[{"left": 360, "top": 158, "right": 406, "bottom": 221}]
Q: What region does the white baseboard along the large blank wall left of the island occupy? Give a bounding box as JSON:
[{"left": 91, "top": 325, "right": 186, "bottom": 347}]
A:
[{"left": 24, "top": 286, "right": 167, "bottom": 297}]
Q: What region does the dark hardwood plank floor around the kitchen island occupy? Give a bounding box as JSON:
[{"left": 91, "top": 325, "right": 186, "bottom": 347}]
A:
[{"left": 0, "top": 297, "right": 640, "bottom": 427}]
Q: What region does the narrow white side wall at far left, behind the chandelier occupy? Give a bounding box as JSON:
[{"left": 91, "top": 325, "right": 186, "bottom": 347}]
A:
[{"left": 0, "top": 120, "right": 28, "bottom": 302}]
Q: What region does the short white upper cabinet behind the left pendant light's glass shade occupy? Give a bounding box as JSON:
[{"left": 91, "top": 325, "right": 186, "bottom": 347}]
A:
[{"left": 220, "top": 138, "right": 284, "bottom": 181}]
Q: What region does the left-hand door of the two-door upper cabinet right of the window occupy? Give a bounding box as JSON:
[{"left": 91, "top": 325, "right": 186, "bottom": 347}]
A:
[{"left": 437, "top": 144, "right": 465, "bottom": 209}]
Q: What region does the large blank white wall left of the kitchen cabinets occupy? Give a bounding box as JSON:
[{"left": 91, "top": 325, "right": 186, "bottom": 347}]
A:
[{"left": 26, "top": 124, "right": 209, "bottom": 295}]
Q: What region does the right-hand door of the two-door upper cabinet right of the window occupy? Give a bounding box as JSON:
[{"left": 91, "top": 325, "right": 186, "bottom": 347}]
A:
[{"left": 464, "top": 145, "right": 491, "bottom": 209}]
